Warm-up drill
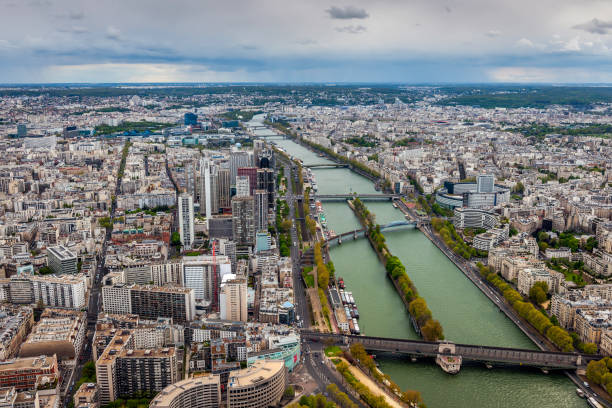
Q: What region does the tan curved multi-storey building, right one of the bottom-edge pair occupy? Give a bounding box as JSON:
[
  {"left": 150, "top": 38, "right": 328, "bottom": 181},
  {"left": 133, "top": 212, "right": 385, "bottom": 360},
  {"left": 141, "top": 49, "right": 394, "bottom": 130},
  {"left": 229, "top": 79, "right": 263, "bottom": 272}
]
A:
[{"left": 227, "top": 360, "right": 287, "bottom": 408}]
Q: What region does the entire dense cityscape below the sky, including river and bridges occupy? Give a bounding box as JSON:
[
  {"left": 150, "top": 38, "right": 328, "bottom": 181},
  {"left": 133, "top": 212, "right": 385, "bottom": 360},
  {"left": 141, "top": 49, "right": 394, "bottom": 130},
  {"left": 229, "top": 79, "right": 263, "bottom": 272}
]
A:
[{"left": 0, "top": 84, "right": 612, "bottom": 408}]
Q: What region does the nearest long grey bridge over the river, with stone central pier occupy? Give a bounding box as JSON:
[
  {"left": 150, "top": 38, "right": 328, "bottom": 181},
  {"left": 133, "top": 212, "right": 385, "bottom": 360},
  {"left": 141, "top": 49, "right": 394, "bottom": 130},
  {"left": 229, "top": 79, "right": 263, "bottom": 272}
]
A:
[{"left": 301, "top": 331, "right": 601, "bottom": 370}]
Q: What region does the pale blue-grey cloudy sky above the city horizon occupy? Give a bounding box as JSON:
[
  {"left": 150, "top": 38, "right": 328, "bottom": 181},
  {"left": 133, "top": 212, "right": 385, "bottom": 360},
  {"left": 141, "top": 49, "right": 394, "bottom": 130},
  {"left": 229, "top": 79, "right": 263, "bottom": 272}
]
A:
[{"left": 0, "top": 0, "right": 612, "bottom": 83}]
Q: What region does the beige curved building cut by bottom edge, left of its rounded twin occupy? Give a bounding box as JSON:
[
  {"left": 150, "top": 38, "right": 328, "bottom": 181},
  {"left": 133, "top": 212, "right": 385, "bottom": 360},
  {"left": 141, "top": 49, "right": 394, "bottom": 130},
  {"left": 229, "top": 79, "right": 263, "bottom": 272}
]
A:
[{"left": 149, "top": 375, "right": 221, "bottom": 408}]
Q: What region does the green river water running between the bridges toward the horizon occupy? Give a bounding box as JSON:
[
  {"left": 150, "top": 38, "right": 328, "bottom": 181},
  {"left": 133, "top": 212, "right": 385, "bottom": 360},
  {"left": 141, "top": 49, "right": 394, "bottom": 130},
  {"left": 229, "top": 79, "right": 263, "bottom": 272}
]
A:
[{"left": 253, "top": 116, "right": 586, "bottom": 408}]
